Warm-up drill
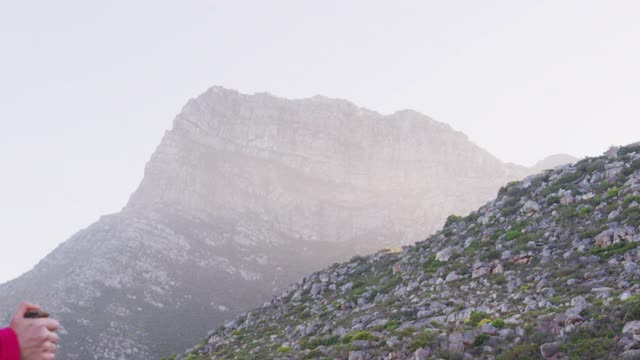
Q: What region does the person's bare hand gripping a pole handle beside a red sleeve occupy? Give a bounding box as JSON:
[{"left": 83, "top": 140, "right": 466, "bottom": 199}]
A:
[{"left": 9, "top": 303, "right": 59, "bottom": 360}]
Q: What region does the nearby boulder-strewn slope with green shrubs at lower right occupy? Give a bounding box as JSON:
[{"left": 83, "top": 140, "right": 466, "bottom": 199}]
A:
[{"left": 177, "top": 143, "right": 640, "bottom": 360}]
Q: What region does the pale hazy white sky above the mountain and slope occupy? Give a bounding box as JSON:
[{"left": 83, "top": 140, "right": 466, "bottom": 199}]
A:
[{"left": 0, "top": 0, "right": 640, "bottom": 282}]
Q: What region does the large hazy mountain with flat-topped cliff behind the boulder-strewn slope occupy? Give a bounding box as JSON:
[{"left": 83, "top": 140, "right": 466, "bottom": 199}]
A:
[{"left": 0, "top": 87, "right": 568, "bottom": 360}]
